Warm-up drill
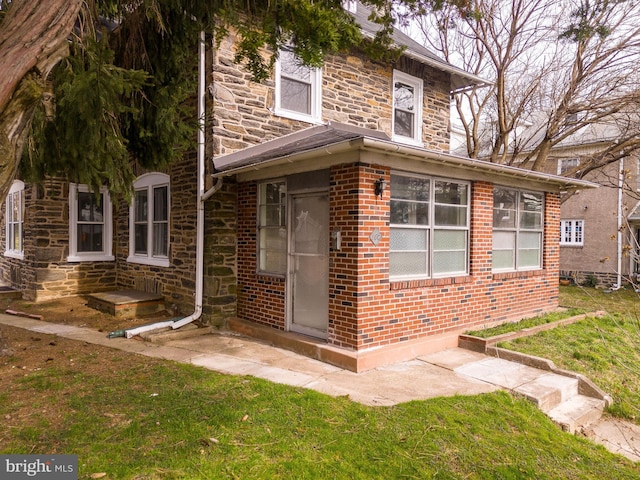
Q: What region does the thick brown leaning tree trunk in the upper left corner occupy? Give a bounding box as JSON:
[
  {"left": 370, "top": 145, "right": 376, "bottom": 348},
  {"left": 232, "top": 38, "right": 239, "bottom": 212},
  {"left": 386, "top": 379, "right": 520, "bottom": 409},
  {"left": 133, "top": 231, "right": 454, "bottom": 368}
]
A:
[{"left": 0, "top": 0, "right": 83, "bottom": 201}]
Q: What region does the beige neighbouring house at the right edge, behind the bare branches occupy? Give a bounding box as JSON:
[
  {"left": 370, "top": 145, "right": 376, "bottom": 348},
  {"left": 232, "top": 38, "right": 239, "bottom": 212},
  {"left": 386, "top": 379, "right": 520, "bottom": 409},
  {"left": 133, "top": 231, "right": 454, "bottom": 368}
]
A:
[{"left": 550, "top": 123, "right": 640, "bottom": 288}]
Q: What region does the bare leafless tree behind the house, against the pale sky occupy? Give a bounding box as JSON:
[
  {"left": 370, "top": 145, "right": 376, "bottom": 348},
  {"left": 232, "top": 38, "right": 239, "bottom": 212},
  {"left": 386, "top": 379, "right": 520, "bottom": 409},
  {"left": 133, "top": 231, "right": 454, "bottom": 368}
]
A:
[{"left": 420, "top": 0, "right": 640, "bottom": 176}]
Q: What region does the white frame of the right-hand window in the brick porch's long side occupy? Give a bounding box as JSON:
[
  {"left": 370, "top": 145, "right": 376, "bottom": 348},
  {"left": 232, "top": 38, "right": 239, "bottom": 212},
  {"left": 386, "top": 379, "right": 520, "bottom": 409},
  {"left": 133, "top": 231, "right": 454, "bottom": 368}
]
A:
[{"left": 492, "top": 185, "right": 545, "bottom": 273}]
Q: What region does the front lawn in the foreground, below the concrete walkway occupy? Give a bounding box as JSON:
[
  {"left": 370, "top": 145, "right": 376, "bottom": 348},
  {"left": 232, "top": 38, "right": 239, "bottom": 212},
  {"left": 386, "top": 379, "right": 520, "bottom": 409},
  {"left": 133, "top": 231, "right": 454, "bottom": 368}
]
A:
[{"left": 0, "top": 358, "right": 640, "bottom": 480}]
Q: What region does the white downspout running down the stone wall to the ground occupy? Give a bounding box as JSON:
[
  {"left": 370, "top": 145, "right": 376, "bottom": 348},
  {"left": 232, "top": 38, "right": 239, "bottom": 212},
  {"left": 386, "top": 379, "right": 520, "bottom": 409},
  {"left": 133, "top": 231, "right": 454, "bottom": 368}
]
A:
[{"left": 122, "top": 32, "right": 222, "bottom": 338}]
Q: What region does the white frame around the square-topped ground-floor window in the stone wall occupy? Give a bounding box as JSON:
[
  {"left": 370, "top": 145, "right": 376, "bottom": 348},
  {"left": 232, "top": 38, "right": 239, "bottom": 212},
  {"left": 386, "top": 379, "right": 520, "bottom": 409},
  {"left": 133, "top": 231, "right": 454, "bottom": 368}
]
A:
[{"left": 67, "top": 183, "right": 115, "bottom": 262}]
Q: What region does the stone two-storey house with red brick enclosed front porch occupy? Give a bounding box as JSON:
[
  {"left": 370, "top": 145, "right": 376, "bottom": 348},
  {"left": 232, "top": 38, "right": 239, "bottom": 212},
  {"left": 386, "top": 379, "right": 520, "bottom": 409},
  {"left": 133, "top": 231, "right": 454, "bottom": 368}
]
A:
[{"left": 0, "top": 2, "right": 591, "bottom": 371}]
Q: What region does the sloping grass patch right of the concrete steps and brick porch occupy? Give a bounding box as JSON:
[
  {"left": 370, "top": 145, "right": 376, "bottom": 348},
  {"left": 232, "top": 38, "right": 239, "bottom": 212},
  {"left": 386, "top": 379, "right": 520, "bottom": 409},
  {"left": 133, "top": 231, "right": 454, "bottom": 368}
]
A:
[{"left": 499, "top": 287, "right": 640, "bottom": 423}]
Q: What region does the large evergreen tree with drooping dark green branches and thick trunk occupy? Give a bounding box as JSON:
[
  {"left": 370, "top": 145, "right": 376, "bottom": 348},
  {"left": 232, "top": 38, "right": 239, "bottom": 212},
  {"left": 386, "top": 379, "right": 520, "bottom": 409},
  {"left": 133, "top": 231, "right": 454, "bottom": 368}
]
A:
[{"left": 0, "top": 0, "right": 476, "bottom": 202}]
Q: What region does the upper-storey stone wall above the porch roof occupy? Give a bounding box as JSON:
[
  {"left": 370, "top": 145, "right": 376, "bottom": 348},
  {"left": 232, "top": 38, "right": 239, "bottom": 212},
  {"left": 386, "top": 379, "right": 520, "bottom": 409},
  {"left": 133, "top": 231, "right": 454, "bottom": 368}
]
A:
[{"left": 209, "top": 32, "right": 450, "bottom": 155}]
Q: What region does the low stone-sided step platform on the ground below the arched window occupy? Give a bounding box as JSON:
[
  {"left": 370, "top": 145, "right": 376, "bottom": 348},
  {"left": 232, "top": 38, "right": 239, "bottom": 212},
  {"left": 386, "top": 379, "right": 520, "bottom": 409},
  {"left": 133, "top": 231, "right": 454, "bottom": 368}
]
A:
[{"left": 87, "top": 290, "right": 165, "bottom": 318}]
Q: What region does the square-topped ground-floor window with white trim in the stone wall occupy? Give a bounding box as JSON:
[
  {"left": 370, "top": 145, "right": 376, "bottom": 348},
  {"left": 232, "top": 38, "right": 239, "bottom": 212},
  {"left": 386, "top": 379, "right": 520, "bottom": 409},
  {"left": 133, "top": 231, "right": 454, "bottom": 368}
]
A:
[{"left": 67, "top": 183, "right": 114, "bottom": 262}]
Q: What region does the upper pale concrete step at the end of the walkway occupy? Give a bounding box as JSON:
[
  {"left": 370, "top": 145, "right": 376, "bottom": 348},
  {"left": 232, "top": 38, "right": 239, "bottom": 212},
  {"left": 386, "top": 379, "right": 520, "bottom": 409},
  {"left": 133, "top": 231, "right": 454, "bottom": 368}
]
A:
[{"left": 514, "top": 373, "right": 579, "bottom": 413}]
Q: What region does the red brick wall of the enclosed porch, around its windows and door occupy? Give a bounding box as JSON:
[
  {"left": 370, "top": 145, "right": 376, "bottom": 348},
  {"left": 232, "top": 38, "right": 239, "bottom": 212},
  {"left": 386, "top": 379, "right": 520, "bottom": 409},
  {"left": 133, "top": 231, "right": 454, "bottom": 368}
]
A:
[{"left": 238, "top": 171, "right": 560, "bottom": 350}]
